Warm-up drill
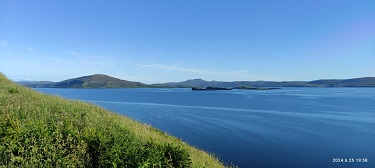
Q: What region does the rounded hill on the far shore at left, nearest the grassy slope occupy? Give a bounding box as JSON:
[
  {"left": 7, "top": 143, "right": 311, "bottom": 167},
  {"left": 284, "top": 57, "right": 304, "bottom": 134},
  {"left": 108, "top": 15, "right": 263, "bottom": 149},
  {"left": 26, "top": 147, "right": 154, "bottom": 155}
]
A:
[{"left": 21, "top": 74, "right": 148, "bottom": 88}]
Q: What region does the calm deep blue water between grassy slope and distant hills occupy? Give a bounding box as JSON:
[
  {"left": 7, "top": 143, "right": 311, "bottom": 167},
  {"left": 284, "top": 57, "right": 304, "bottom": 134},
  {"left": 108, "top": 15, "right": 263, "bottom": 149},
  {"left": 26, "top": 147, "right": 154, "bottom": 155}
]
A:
[{"left": 36, "top": 88, "right": 375, "bottom": 167}]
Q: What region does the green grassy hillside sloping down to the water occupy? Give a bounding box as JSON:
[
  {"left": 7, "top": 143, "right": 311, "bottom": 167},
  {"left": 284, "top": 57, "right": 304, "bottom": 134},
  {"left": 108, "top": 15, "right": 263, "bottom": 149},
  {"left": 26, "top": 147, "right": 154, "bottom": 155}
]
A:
[{"left": 0, "top": 74, "right": 223, "bottom": 167}]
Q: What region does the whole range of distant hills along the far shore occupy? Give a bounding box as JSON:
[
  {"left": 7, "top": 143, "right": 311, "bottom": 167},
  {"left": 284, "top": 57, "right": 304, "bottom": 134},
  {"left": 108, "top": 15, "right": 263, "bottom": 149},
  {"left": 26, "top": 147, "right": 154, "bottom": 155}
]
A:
[{"left": 17, "top": 74, "right": 375, "bottom": 88}]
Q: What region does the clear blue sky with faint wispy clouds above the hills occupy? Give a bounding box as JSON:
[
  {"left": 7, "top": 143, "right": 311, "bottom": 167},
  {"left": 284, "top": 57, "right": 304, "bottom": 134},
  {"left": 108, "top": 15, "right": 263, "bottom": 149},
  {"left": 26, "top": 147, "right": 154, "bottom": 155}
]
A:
[{"left": 0, "top": 0, "right": 375, "bottom": 84}]
